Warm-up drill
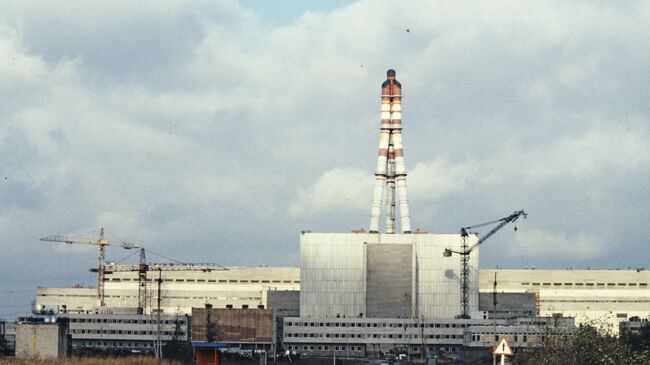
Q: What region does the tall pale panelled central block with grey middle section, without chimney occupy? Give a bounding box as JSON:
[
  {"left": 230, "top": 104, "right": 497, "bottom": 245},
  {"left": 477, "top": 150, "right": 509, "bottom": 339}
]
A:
[{"left": 300, "top": 233, "right": 479, "bottom": 319}]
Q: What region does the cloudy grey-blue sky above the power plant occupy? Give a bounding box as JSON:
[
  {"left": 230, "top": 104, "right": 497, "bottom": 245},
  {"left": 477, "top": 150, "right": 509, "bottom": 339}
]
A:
[{"left": 0, "top": 0, "right": 650, "bottom": 318}]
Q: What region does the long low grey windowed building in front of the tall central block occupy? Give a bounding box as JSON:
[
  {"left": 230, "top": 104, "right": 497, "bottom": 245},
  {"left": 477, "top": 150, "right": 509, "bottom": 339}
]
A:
[{"left": 283, "top": 317, "right": 575, "bottom": 357}]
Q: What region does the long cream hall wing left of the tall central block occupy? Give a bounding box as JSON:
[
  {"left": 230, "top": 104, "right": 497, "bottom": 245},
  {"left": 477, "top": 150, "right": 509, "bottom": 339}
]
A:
[{"left": 36, "top": 264, "right": 300, "bottom": 314}]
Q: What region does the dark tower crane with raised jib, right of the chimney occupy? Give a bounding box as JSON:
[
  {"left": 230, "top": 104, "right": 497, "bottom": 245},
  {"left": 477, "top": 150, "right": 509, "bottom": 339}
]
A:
[{"left": 443, "top": 210, "right": 528, "bottom": 318}]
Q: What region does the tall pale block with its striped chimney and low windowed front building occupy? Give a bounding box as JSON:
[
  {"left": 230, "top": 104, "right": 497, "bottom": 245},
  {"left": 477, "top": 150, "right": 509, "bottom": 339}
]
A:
[{"left": 283, "top": 70, "right": 496, "bottom": 357}]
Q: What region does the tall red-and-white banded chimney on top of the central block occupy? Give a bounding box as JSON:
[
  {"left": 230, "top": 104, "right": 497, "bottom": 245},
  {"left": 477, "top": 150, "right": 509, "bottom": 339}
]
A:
[{"left": 370, "top": 69, "right": 411, "bottom": 234}]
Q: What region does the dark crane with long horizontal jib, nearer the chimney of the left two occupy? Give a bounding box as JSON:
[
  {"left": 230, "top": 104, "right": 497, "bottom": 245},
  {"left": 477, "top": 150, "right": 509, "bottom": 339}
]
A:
[{"left": 95, "top": 248, "right": 230, "bottom": 314}]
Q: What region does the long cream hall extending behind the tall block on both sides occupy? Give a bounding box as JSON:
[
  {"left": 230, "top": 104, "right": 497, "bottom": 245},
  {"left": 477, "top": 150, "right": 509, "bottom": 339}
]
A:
[{"left": 36, "top": 266, "right": 650, "bottom": 332}]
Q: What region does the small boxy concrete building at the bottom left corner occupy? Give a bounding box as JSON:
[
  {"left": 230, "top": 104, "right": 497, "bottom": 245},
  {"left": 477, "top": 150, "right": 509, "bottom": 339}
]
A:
[{"left": 16, "top": 323, "right": 68, "bottom": 359}]
